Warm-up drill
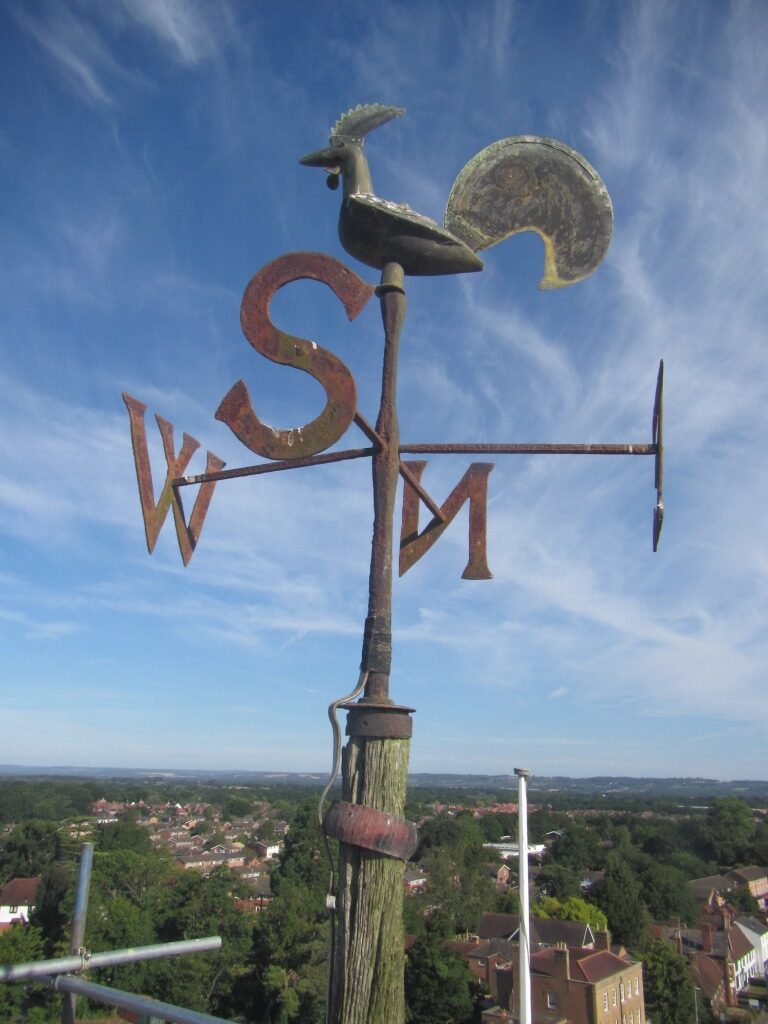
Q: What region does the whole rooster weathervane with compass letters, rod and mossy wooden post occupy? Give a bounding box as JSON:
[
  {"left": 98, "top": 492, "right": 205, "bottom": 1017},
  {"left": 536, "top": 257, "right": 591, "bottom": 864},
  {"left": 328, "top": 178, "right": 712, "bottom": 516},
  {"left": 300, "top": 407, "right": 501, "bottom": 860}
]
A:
[{"left": 124, "top": 103, "right": 664, "bottom": 1024}]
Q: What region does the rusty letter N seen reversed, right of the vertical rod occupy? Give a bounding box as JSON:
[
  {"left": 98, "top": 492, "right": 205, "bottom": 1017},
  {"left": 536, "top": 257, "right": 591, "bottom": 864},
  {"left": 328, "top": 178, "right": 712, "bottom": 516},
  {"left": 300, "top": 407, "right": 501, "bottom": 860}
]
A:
[{"left": 399, "top": 462, "right": 494, "bottom": 580}]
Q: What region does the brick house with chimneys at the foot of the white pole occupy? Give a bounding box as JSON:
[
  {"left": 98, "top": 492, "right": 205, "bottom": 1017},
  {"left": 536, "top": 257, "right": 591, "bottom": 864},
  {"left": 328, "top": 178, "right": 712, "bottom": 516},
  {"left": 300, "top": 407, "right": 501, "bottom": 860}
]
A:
[{"left": 482, "top": 933, "right": 645, "bottom": 1024}]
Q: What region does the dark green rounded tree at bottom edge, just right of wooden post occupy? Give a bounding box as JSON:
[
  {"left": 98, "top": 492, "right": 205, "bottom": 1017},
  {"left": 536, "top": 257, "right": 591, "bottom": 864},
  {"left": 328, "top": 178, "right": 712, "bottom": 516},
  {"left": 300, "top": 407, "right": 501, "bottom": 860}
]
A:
[{"left": 406, "top": 936, "right": 474, "bottom": 1024}]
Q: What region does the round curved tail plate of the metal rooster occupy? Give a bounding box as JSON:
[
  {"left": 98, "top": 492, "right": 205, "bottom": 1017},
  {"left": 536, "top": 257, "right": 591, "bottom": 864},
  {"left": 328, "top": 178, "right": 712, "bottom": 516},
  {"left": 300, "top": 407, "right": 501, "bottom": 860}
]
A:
[{"left": 445, "top": 135, "right": 613, "bottom": 288}]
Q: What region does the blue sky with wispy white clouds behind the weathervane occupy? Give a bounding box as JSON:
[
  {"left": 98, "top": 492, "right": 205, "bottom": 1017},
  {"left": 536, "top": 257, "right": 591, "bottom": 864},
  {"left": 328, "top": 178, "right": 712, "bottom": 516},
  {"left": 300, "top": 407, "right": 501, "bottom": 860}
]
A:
[{"left": 0, "top": 0, "right": 768, "bottom": 778}]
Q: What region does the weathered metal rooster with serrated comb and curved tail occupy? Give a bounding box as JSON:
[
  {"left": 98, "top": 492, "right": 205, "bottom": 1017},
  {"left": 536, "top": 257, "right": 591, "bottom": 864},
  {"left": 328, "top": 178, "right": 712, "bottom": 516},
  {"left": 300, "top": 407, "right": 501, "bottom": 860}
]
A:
[{"left": 301, "top": 103, "right": 613, "bottom": 288}]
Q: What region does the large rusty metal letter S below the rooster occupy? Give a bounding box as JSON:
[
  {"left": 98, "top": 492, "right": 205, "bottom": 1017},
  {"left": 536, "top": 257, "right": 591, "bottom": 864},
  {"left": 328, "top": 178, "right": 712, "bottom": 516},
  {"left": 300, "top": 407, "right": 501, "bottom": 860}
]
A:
[{"left": 216, "top": 253, "right": 374, "bottom": 459}]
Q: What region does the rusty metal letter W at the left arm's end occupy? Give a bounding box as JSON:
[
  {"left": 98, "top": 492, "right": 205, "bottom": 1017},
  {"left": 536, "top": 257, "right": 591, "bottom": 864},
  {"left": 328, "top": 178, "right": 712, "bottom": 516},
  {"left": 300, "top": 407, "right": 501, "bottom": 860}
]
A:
[{"left": 123, "top": 393, "right": 226, "bottom": 565}]
